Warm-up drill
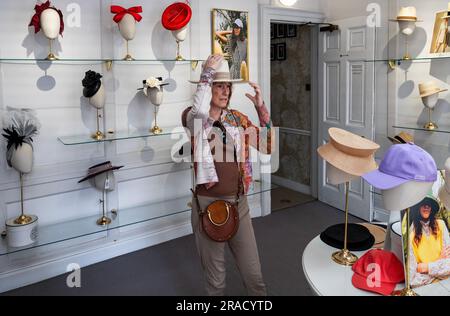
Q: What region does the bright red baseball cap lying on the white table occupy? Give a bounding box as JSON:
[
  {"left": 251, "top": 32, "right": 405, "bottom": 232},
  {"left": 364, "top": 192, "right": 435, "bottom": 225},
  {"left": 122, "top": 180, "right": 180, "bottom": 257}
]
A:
[{"left": 352, "top": 249, "right": 405, "bottom": 295}]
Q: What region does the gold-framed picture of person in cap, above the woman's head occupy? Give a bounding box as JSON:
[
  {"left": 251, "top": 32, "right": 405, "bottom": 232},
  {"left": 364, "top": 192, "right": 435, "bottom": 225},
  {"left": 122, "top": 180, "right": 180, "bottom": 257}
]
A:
[{"left": 211, "top": 9, "right": 250, "bottom": 81}]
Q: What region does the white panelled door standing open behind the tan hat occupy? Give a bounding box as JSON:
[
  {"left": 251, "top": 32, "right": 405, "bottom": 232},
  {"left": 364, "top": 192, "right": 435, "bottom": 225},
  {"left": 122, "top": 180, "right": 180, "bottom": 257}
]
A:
[{"left": 318, "top": 17, "right": 375, "bottom": 220}]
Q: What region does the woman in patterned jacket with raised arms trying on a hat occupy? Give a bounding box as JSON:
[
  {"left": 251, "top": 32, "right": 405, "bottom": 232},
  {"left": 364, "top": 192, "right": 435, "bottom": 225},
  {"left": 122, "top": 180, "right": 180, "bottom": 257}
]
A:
[{"left": 182, "top": 55, "right": 272, "bottom": 296}]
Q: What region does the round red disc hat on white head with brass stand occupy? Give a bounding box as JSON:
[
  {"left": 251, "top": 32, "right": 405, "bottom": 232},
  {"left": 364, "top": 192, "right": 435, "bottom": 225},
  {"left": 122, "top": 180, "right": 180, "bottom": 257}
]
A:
[{"left": 161, "top": 2, "right": 192, "bottom": 60}]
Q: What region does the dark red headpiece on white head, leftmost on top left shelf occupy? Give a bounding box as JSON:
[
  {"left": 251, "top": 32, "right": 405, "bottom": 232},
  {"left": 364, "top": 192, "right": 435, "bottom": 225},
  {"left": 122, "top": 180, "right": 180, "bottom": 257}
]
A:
[{"left": 28, "top": 0, "right": 64, "bottom": 60}]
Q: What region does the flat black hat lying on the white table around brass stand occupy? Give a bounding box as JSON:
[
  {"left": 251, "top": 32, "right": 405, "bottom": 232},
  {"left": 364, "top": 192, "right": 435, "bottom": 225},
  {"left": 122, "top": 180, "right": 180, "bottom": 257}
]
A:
[{"left": 320, "top": 224, "right": 375, "bottom": 251}]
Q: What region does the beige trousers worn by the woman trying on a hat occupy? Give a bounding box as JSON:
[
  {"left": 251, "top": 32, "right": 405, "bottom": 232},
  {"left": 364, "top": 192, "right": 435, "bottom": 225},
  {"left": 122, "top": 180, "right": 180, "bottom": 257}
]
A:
[{"left": 191, "top": 196, "right": 267, "bottom": 296}]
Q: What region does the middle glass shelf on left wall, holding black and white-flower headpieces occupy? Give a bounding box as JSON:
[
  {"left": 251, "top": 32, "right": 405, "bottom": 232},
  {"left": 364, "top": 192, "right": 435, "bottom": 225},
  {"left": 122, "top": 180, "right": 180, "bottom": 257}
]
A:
[{"left": 58, "top": 126, "right": 185, "bottom": 146}]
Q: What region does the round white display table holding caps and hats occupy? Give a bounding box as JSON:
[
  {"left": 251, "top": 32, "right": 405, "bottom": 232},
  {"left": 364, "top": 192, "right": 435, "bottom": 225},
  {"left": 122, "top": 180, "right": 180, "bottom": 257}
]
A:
[{"left": 302, "top": 236, "right": 450, "bottom": 296}]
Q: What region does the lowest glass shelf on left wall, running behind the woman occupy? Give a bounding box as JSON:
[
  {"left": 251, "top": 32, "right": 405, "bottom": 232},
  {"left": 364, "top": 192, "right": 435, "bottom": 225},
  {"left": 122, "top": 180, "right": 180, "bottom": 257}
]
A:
[{"left": 0, "top": 181, "right": 278, "bottom": 256}]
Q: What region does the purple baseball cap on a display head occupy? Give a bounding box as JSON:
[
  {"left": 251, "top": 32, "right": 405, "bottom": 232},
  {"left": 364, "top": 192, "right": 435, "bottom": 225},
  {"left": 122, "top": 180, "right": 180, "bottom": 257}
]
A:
[{"left": 362, "top": 143, "right": 437, "bottom": 190}]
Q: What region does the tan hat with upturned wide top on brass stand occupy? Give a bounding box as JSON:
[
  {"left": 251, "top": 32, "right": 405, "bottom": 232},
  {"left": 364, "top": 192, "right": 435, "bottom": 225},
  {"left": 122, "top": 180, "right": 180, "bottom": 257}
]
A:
[{"left": 317, "top": 127, "right": 380, "bottom": 176}]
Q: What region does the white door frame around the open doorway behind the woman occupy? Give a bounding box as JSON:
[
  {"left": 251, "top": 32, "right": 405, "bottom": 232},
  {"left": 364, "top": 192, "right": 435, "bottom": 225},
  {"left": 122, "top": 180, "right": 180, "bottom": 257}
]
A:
[{"left": 259, "top": 5, "right": 325, "bottom": 204}]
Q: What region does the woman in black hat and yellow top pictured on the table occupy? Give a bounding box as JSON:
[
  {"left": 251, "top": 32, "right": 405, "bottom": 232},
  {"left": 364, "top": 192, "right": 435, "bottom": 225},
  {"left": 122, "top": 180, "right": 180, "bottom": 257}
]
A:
[{"left": 409, "top": 197, "right": 450, "bottom": 286}]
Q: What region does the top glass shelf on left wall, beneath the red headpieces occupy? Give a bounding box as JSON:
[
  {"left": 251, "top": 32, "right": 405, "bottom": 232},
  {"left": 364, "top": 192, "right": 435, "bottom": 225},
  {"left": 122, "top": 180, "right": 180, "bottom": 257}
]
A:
[{"left": 0, "top": 58, "right": 203, "bottom": 65}]
